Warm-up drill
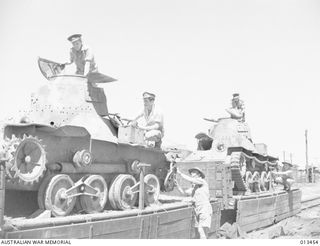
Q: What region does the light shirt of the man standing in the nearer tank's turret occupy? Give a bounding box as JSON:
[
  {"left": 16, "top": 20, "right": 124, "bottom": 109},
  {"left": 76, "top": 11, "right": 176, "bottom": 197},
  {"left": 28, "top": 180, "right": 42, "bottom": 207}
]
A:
[{"left": 70, "top": 45, "right": 98, "bottom": 75}]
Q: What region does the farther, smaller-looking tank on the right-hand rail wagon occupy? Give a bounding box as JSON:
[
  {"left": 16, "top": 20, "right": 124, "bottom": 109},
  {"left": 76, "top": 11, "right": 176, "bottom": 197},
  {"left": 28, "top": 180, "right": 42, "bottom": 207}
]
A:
[{"left": 189, "top": 113, "right": 278, "bottom": 195}]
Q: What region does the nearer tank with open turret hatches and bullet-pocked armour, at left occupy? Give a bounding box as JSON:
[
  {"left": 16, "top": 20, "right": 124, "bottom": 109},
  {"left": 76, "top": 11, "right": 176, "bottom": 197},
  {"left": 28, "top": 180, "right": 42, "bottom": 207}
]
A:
[{"left": 2, "top": 58, "right": 169, "bottom": 216}]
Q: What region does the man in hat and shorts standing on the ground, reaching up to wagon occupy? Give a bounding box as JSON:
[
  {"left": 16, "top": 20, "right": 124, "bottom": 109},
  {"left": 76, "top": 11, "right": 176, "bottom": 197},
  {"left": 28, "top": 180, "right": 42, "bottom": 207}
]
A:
[{"left": 176, "top": 167, "right": 212, "bottom": 239}]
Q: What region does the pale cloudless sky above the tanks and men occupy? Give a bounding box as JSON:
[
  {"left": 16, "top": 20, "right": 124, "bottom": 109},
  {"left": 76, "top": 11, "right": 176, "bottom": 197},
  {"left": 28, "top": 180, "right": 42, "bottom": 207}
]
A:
[{"left": 0, "top": 0, "right": 320, "bottom": 166}]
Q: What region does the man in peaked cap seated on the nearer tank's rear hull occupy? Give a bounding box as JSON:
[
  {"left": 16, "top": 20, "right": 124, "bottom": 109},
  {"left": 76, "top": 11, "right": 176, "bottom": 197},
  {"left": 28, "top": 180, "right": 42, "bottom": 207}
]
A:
[{"left": 130, "top": 92, "right": 164, "bottom": 148}]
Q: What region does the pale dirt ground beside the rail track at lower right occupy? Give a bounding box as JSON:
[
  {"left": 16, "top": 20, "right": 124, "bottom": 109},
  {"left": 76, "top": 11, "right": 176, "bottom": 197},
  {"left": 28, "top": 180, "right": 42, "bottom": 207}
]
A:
[{"left": 246, "top": 183, "right": 320, "bottom": 239}]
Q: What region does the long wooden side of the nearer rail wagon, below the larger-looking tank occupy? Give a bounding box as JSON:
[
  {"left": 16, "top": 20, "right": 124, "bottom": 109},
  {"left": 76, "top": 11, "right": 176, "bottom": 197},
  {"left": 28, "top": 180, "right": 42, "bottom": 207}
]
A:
[{"left": 2, "top": 201, "right": 220, "bottom": 239}]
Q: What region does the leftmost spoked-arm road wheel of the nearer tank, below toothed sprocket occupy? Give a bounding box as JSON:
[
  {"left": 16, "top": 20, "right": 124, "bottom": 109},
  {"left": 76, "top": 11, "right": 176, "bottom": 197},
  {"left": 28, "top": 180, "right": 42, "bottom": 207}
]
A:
[{"left": 45, "top": 174, "right": 76, "bottom": 217}]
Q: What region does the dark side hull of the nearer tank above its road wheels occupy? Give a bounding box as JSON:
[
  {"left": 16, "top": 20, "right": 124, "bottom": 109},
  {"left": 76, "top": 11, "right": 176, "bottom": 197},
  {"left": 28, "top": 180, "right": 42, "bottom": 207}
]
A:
[{"left": 5, "top": 124, "right": 169, "bottom": 190}]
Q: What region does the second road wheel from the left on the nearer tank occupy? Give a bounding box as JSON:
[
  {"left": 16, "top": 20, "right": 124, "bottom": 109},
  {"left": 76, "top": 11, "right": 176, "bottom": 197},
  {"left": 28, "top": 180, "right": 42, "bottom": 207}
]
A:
[{"left": 79, "top": 175, "right": 108, "bottom": 213}]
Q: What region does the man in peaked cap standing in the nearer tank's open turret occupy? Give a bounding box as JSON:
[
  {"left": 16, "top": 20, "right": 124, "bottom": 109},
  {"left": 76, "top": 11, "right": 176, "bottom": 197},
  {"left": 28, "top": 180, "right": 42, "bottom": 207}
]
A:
[{"left": 61, "top": 34, "right": 98, "bottom": 76}]
